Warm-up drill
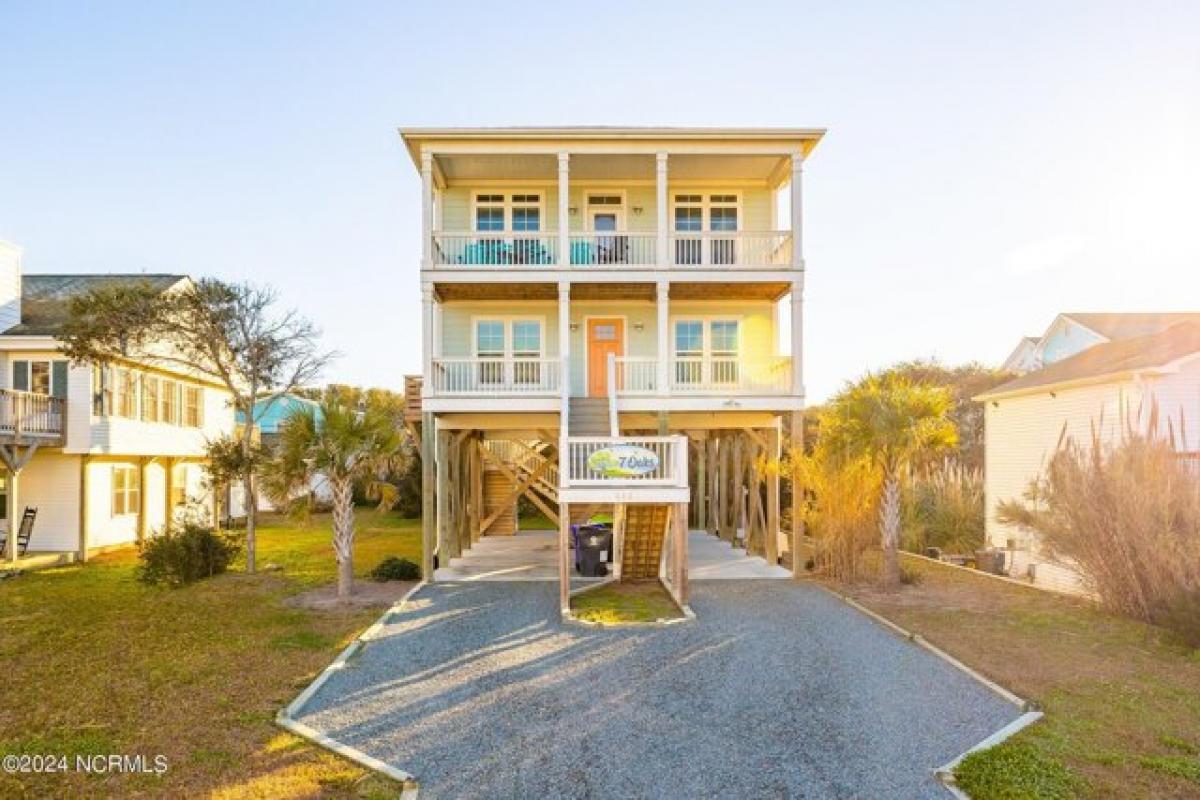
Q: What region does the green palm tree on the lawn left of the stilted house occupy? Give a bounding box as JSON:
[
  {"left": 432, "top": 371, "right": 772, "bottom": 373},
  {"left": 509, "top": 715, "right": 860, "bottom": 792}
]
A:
[{"left": 265, "top": 395, "right": 403, "bottom": 597}]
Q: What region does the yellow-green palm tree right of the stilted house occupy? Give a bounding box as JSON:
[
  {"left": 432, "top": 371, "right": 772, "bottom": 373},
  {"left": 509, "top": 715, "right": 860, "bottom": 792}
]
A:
[{"left": 821, "top": 373, "right": 958, "bottom": 588}]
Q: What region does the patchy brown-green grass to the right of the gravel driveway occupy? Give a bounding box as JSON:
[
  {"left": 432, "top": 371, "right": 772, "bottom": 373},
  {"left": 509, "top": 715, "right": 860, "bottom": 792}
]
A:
[{"left": 838, "top": 559, "right": 1200, "bottom": 800}]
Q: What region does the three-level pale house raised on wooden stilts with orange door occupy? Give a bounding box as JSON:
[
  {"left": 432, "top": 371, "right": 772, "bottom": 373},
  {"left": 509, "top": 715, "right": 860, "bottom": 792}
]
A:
[{"left": 401, "top": 127, "right": 823, "bottom": 603}]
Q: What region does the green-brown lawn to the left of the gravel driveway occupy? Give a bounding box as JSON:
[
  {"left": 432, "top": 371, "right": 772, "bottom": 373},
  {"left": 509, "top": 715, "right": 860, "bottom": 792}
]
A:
[{"left": 0, "top": 511, "right": 420, "bottom": 799}]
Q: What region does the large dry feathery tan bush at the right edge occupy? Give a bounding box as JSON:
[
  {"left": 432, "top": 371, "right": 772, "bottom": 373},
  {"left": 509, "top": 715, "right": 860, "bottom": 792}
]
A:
[{"left": 998, "top": 411, "right": 1200, "bottom": 646}]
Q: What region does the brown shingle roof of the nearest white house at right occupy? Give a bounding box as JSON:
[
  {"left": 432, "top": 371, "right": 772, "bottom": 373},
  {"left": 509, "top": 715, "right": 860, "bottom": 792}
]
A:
[{"left": 974, "top": 314, "right": 1200, "bottom": 401}]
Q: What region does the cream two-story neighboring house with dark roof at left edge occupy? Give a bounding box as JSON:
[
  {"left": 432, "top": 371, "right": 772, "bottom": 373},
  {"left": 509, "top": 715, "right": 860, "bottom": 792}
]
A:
[{"left": 0, "top": 242, "right": 234, "bottom": 566}]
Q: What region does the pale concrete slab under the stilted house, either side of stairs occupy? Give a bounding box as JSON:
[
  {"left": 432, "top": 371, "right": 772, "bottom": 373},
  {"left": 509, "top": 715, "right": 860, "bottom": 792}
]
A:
[{"left": 433, "top": 530, "right": 791, "bottom": 581}]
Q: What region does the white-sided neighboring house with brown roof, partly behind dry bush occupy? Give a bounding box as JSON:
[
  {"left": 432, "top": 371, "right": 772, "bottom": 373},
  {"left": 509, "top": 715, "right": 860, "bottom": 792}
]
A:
[{"left": 976, "top": 314, "right": 1200, "bottom": 591}]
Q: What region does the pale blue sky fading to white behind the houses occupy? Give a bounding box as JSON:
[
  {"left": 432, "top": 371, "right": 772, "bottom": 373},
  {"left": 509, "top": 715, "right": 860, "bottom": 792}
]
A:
[{"left": 0, "top": 0, "right": 1200, "bottom": 399}]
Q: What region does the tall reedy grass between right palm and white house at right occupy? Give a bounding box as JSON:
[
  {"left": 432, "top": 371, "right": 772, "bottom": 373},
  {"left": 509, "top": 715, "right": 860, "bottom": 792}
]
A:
[{"left": 901, "top": 458, "right": 984, "bottom": 553}]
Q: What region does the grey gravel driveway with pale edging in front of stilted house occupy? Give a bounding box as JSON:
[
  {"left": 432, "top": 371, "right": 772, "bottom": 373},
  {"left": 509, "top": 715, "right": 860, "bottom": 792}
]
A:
[{"left": 299, "top": 581, "right": 1019, "bottom": 800}]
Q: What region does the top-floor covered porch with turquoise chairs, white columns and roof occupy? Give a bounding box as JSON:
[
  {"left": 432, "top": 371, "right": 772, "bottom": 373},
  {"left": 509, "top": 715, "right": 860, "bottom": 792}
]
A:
[{"left": 402, "top": 128, "right": 822, "bottom": 275}]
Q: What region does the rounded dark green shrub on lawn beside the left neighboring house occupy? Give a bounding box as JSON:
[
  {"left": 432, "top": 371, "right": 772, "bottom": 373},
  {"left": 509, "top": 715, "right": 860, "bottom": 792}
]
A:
[{"left": 138, "top": 521, "right": 241, "bottom": 587}]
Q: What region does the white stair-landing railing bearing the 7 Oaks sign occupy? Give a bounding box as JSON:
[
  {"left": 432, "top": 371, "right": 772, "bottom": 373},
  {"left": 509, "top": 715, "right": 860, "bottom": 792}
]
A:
[{"left": 562, "top": 437, "right": 688, "bottom": 488}]
